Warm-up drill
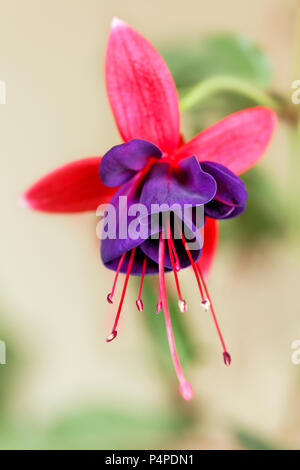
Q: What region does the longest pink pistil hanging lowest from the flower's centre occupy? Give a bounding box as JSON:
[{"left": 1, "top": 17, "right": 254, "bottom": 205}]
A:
[{"left": 158, "top": 232, "right": 193, "bottom": 400}]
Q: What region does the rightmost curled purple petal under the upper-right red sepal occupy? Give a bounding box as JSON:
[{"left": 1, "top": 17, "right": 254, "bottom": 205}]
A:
[{"left": 201, "top": 162, "right": 248, "bottom": 219}]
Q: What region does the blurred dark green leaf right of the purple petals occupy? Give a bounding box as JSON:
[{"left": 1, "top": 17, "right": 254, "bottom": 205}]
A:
[{"left": 221, "top": 168, "right": 287, "bottom": 244}]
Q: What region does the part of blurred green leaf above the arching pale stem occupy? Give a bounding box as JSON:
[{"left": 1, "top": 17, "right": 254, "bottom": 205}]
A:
[{"left": 162, "top": 34, "right": 272, "bottom": 88}]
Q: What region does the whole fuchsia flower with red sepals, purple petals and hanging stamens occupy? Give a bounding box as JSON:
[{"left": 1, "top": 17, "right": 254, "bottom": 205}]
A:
[{"left": 23, "top": 19, "right": 276, "bottom": 399}]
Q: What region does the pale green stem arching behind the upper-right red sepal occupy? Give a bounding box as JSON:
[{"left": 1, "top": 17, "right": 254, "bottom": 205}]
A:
[{"left": 180, "top": 75, "right": 280, "bottom": 111}]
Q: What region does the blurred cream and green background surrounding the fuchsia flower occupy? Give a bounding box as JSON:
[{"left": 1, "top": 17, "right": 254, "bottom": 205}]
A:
[{"left": 0, "top": 0, "right": 300, "bottom": 449}]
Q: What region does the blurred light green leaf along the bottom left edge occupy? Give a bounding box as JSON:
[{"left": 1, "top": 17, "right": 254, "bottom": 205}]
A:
[{"left": 0, "top": 407, "right": 187, "bottom": 449}]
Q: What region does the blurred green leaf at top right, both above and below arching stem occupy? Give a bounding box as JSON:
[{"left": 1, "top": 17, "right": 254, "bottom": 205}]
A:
[{"left": 162, "top": 34, "right": 272, "bottom": 132}]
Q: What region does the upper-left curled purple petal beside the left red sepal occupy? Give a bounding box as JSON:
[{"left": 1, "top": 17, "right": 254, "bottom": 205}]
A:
[{"left": 99, "top": 139, "right": 162, "bottom": 187}]
